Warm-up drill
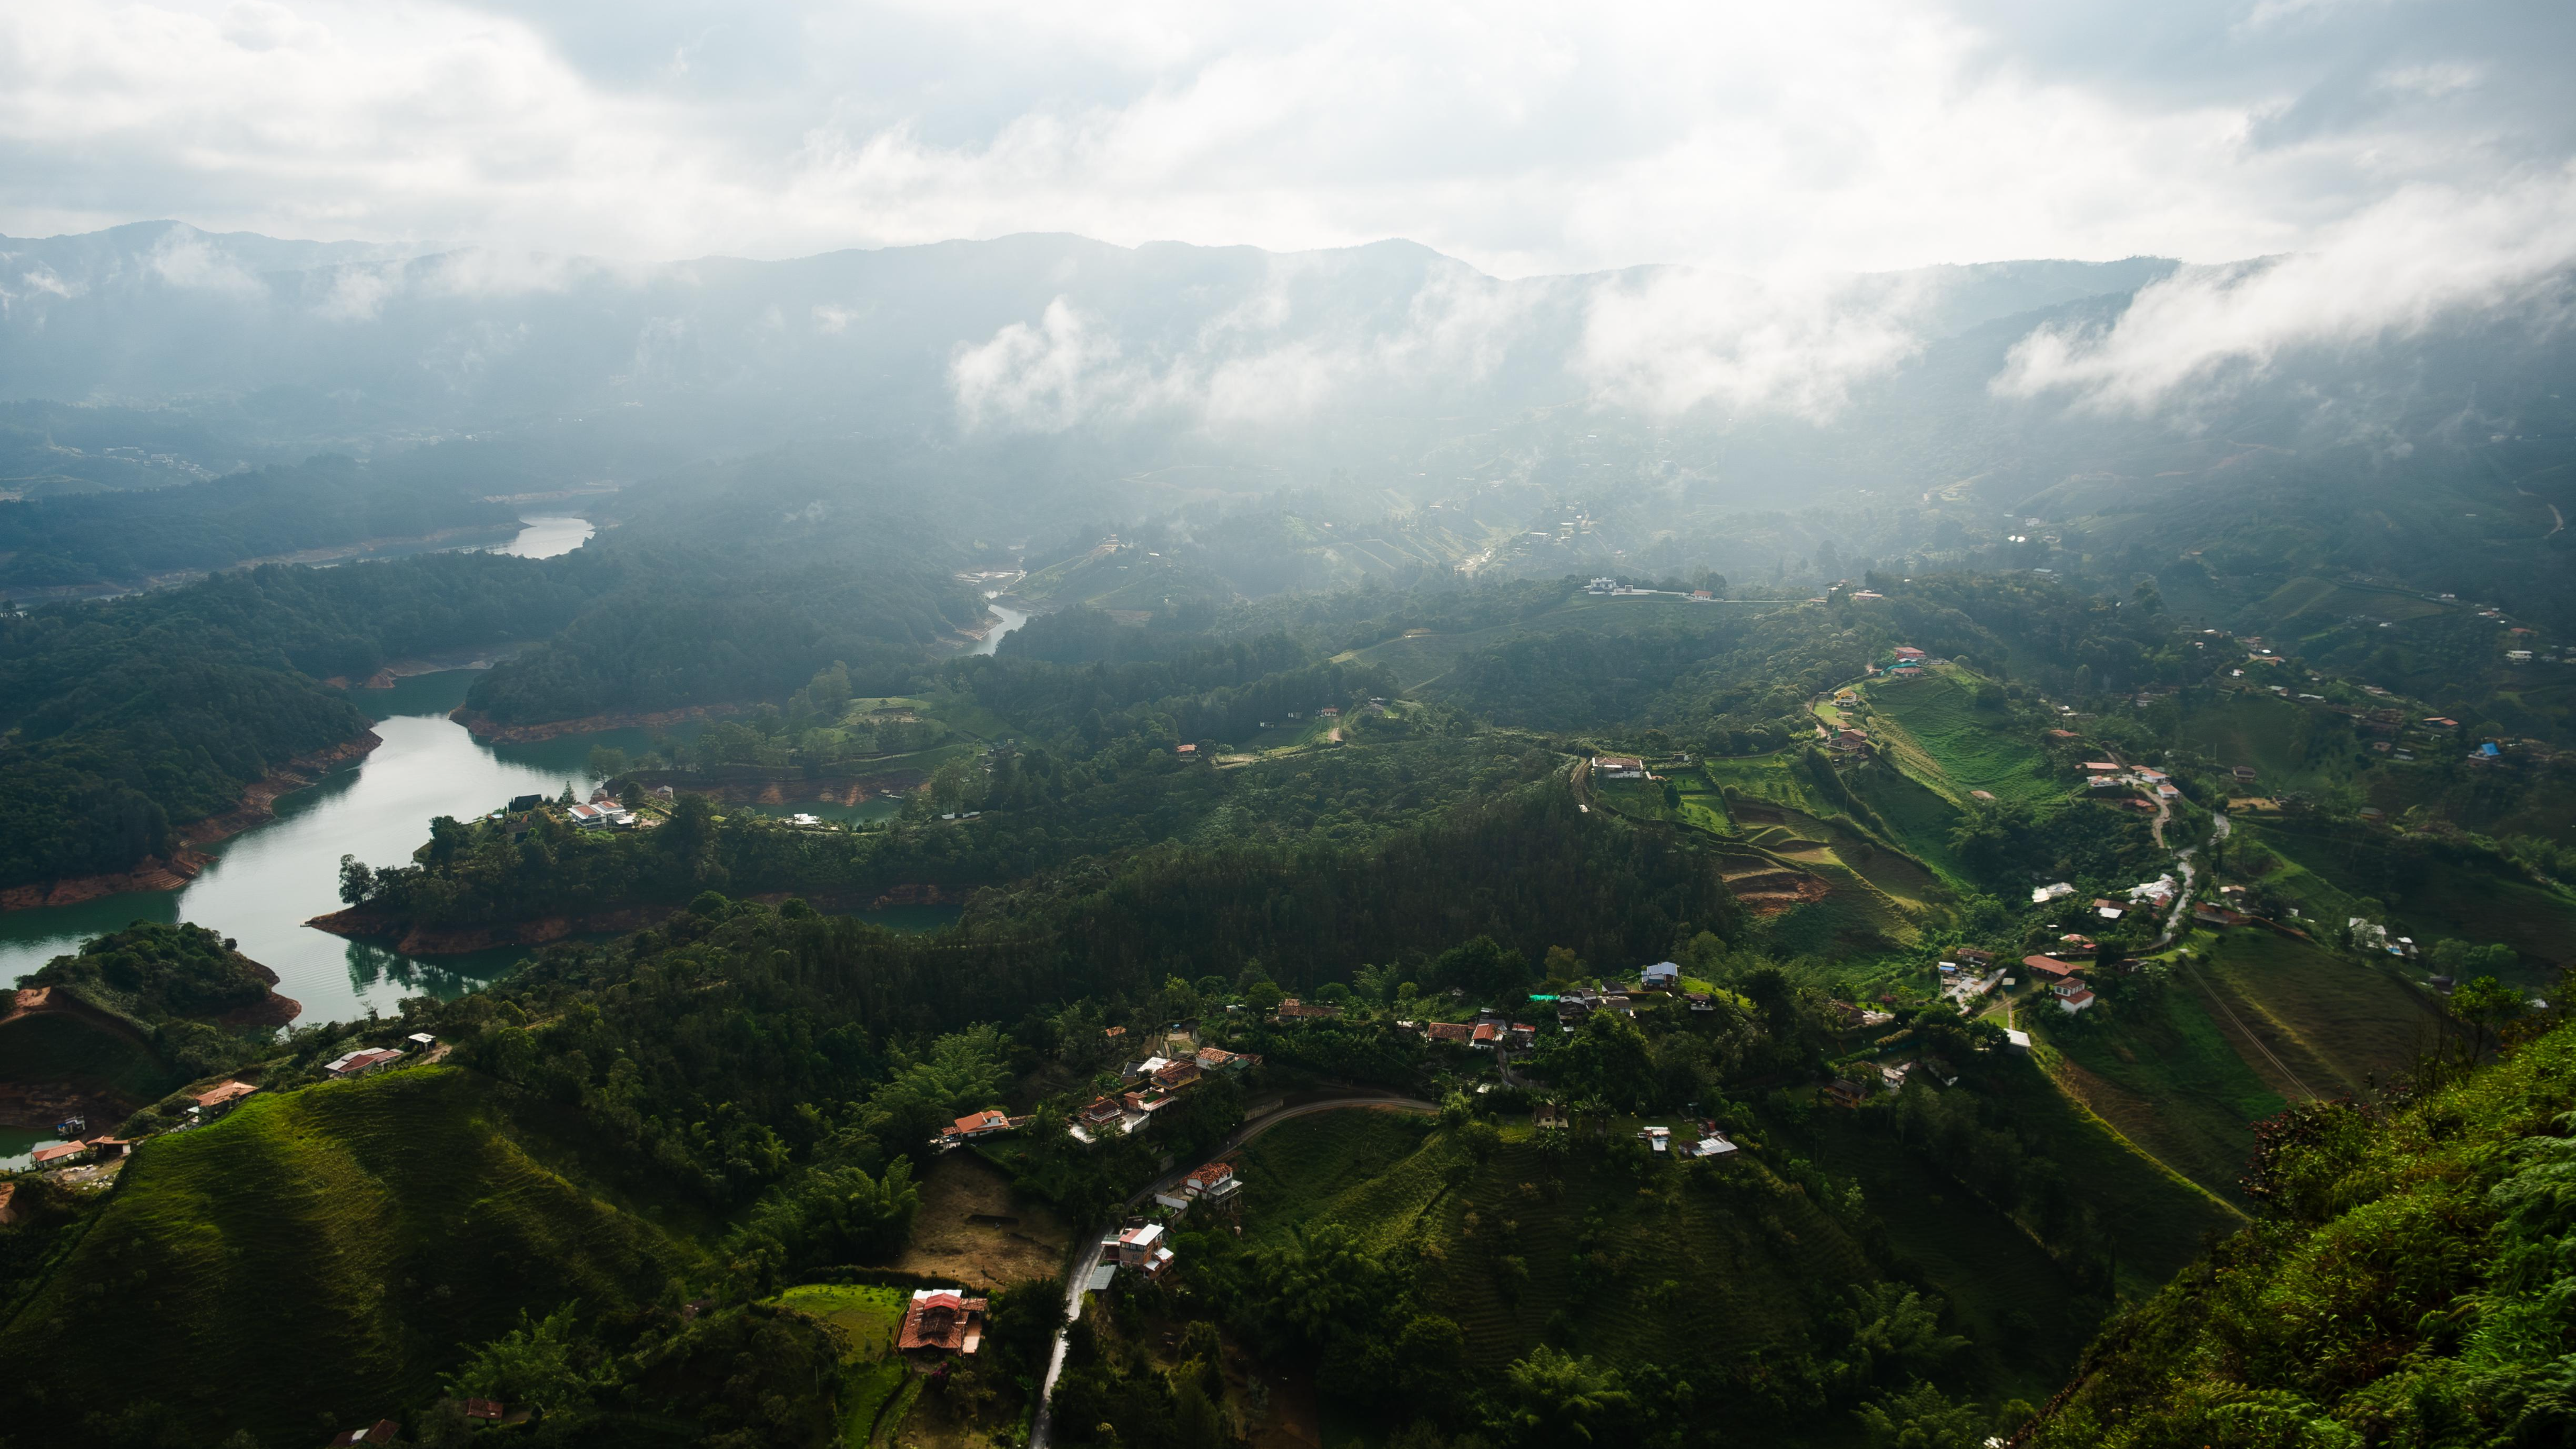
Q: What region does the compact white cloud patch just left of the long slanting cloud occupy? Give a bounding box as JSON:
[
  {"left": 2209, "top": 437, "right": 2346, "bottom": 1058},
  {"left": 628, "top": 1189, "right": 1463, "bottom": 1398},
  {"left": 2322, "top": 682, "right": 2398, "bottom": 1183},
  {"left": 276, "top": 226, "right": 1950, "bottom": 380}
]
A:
[{"left": 1576, "top": 271, "right": 1929, "bottom": 423}]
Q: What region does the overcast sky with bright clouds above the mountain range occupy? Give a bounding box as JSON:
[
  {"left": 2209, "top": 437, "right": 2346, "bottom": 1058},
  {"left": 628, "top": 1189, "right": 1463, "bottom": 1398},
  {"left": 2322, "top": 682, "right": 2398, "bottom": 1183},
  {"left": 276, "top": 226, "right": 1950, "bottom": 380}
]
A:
[{"left": 0, "top": 0, "right": 2576, "bottom": 276}]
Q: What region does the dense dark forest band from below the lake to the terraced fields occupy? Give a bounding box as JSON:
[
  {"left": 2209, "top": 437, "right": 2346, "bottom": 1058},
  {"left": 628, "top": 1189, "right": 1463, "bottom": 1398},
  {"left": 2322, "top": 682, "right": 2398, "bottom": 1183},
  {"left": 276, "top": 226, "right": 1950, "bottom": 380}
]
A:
[{"left": 410, "top": 789, "right": 1739, "bottom": 1201}]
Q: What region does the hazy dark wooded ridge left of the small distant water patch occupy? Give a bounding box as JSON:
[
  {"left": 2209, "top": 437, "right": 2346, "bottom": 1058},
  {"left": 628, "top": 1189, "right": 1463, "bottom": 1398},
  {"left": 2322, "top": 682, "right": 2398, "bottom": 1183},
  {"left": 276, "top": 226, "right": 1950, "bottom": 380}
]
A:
[{"left": 0, "top": 453, "right": 518, "bottom": 588}]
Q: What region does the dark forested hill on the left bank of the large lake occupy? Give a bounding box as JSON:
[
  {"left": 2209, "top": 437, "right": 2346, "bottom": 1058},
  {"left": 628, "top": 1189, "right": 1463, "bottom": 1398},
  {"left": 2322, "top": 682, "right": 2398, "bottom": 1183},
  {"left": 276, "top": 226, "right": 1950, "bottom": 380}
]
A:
[{"left": 0, "top": 554, "right": 588, "bottom": 884}]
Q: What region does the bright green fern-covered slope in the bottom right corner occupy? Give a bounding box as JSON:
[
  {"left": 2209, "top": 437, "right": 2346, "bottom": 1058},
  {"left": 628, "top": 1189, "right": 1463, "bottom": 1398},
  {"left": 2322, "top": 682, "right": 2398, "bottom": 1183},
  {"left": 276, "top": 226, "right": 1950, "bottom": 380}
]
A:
[{"left": 2030, "top": 1026, "right": 2576, "bottom": 1449}]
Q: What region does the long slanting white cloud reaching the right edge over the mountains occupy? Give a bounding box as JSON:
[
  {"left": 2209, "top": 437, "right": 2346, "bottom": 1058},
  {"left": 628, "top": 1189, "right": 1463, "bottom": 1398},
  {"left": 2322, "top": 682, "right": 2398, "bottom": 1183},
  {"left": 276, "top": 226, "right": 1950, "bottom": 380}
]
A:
[{"left": 1991, "top": 165, "right": 2576, "bottom": 413}]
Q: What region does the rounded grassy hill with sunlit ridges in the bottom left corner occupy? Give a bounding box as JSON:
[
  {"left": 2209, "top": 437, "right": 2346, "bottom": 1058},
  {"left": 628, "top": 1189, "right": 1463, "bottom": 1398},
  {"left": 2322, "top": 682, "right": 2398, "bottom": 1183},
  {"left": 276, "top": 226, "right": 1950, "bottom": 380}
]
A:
[{"left": 0, "top": 1067, "right": 690, "bottom": 1444}]
